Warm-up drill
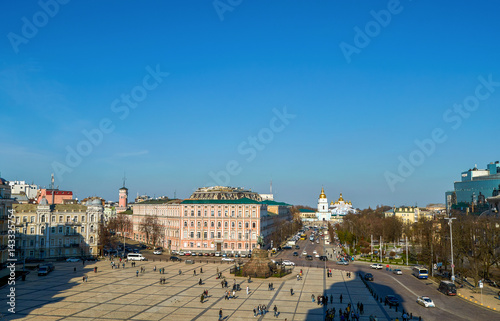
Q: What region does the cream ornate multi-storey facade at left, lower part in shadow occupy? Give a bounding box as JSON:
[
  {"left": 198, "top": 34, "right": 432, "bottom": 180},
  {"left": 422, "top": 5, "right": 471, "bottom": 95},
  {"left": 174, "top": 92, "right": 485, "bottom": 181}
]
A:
[{"left": 13, "top": 198, "right": 103, "bottom": 259}]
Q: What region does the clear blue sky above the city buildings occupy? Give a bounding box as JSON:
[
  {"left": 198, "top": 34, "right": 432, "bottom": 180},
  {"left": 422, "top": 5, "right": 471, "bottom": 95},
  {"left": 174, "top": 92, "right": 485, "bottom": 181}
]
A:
[{"left": 0, "top": 0, "right": 500, "bottom": 208}]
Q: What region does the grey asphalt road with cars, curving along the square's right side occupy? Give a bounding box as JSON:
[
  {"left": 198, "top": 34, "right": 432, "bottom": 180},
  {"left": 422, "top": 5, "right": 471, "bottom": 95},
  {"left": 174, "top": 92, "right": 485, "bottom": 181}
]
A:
[{"left": 276, "top": 228, "right": 500, "bottom": 320}]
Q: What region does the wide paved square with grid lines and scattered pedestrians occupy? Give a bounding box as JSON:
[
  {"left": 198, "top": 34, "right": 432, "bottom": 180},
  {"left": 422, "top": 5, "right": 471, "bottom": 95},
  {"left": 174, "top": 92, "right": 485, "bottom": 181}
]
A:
[{"left": 0, "top": 259, "right": 396, "bottom": 321}]
